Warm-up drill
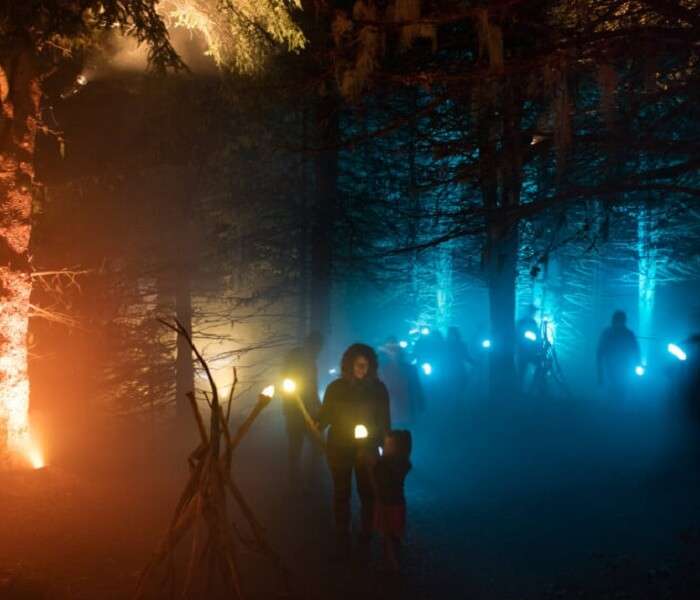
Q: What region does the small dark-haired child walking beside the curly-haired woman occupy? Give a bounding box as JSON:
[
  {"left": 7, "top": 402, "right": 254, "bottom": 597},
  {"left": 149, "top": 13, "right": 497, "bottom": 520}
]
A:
[{"left": 372, "top": 430, "right": 412, "bottom": 571}]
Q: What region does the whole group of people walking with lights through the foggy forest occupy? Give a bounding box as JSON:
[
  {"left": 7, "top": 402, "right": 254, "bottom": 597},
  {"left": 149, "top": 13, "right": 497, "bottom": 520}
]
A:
[{"left": 282, "top": 310, "right": 700, "bottom": 569}]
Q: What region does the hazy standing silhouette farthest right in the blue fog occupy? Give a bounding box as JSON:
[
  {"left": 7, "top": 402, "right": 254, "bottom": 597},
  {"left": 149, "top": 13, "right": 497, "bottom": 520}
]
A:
[{"left": 597, "top": 310, "right": 640, "bottom": 400}]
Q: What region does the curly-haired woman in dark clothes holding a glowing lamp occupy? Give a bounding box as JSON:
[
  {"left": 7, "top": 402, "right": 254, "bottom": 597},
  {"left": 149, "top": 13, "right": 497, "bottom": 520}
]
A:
[{"left": 318, "top": 344, "right": 391, "bottom": 558}]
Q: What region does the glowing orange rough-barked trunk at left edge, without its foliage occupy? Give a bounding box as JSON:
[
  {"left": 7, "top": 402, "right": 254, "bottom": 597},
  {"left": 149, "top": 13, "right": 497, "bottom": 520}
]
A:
[{"left": 0, "top": 46, "right": 41, "bottom": 451}]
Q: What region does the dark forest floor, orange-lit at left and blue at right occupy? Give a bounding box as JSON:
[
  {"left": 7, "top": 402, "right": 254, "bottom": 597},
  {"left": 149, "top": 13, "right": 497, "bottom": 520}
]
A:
[{"left": 0, "top": 386, "right": 700, "bottom": 600}]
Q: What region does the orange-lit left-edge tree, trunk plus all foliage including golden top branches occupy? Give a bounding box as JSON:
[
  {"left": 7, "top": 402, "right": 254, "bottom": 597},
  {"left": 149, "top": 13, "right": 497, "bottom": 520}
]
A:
[{"left": 0, "top": 0, "right": 305, "bottom": 466}]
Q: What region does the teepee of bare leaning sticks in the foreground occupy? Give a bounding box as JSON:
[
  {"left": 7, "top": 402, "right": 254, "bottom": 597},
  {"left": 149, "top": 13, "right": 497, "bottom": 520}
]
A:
[{"left": 135, "top": 320, "right": 291, "bottom": 600}]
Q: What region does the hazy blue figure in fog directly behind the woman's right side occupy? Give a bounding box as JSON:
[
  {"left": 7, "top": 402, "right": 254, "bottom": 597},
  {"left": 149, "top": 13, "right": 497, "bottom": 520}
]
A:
[{"left": 379, "top": 337, "right": 425, "bottom": 427}]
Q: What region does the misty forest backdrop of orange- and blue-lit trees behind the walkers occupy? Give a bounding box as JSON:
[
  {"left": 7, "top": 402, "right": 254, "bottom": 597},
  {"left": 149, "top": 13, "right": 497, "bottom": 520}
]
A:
[{"left": 2, "top": 0, "right": 700, "bottom": 450}]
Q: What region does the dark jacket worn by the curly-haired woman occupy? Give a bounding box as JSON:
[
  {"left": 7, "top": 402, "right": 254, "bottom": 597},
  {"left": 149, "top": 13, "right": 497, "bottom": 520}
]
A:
[{"left": 319, "top": 378, "right": 391, "bottom": 459}]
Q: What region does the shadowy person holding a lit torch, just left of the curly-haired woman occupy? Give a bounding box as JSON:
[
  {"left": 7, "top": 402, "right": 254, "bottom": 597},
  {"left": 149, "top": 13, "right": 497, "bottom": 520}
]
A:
[{"left": 282, "top": 332, "right": 323, "bottom": 488}]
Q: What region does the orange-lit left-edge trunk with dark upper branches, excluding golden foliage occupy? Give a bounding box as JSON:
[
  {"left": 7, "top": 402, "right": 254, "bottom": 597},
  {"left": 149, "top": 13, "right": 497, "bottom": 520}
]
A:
[{"left": 0, "top": 0, "right": 181, "bottom": 460}]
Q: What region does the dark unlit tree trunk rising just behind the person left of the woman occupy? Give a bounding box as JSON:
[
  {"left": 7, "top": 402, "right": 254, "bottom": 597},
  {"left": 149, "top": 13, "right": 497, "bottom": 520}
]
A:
[{"left": 311, "top": 95, "right": 339, "bottom": 336}]
